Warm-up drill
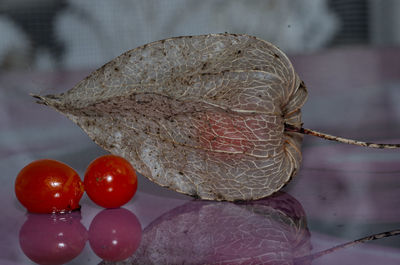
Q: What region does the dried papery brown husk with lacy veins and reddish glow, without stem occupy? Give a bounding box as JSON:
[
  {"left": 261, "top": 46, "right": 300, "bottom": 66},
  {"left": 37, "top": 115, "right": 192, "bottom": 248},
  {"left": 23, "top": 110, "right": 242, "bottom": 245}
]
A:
[{"left": 36, "top": 34, "right": 307, "bottom": 201}]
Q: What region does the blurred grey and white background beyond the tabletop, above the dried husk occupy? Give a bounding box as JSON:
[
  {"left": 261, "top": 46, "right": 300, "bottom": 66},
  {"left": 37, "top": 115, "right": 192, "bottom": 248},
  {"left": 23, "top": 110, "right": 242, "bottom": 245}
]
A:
[{"left": 0, "top": 0, "right": 400, "bottom": 71}]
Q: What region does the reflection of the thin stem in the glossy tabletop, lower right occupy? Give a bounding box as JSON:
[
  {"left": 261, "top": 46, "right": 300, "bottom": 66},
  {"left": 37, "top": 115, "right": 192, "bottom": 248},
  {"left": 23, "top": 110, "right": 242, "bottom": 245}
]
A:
[{"left": 295, "top": 229, "right": 400, "bottom": 264}]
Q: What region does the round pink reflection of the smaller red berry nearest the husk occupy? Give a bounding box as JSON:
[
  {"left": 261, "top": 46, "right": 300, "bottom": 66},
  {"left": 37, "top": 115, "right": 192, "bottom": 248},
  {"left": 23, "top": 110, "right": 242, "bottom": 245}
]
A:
[{"left": 89, "top": 208, "right": 142, "bottom": 261}]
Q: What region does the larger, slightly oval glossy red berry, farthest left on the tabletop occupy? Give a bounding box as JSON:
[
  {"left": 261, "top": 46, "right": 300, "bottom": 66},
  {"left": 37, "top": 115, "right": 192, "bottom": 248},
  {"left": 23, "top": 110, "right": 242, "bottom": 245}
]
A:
[{"left": 15, "top": 159, "right": 84, "bottom": 213}]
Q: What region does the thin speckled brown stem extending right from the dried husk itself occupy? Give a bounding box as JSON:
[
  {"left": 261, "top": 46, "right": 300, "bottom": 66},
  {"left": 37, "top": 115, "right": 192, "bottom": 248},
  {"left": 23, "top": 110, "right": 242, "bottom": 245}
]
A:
[{"left": 285, "top": 123, "right": 400, "bottom": 149}]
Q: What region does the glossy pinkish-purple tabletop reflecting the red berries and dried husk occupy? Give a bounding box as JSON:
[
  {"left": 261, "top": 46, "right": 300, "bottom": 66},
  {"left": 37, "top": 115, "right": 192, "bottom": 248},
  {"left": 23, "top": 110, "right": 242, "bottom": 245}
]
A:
[{"left": 0, "top": 48, "right": 400, "bottom": 265}]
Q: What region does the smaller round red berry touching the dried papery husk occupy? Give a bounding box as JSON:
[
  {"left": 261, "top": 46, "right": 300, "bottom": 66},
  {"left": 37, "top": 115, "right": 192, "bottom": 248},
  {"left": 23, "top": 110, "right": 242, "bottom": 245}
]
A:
[{"left": 84, "top": 155, "right": 137, "bottom": 208}]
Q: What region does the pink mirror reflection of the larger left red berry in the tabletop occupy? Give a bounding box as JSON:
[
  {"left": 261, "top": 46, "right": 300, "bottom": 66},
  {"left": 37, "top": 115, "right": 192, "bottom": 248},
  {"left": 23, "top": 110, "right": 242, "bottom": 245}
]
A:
[{"left": 19, "top": 211, "right": 88, "bottom": 265}]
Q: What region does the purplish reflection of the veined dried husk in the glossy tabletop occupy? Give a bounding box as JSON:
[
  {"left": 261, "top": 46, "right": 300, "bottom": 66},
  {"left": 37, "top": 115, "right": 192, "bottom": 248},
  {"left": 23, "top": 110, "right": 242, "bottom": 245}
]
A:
[{"left": 101, "top": 193, "right": 311, "bottom": 265}]
